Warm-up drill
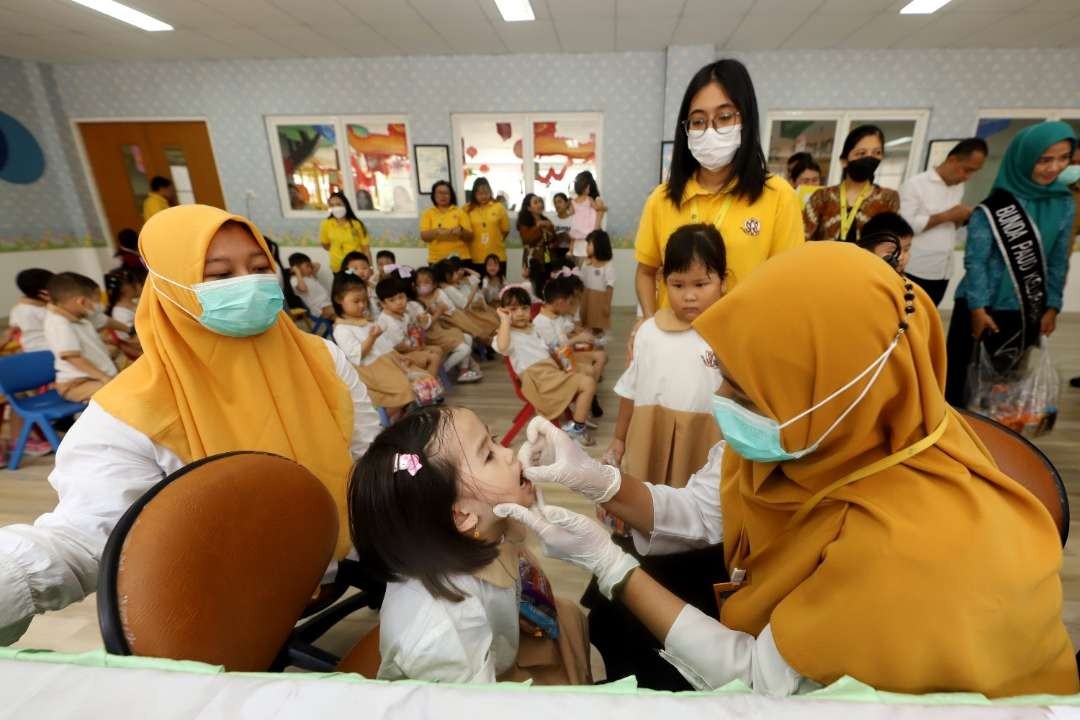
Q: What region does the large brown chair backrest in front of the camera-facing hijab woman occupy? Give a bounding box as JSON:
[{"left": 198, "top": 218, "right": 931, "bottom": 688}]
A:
[{"left": 97, "top": 452, "right": 338, "bottom": 671}]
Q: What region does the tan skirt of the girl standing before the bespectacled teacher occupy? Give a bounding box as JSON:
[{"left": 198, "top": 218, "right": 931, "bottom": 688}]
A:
[{"left": 622, "top": 405, "right": 720, "bottom": 488}]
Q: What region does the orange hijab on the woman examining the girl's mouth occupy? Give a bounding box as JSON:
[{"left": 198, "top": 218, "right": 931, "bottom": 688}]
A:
[{"left": 694, "top": 242, "right": 1078, "bottom": 696}]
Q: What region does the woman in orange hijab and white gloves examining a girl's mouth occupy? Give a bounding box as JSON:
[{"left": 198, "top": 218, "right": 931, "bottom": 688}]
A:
[{"left": 497, "top": 243, "right": 1080, "bottom": 697}]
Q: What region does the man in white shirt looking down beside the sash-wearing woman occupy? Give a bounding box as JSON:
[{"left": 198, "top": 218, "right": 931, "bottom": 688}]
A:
[{"left": 900, "top": 137, "right": 989, "bottom": 304}]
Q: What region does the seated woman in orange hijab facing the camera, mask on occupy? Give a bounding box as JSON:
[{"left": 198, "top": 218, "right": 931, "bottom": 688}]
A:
[{"left": 0, "top": 205, "right": 379, "bottom": 644}]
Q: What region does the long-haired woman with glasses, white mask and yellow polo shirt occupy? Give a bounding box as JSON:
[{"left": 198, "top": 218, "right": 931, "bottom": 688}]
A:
[{"left": 634, "top": 59, "right": 804, "bottom": 317}]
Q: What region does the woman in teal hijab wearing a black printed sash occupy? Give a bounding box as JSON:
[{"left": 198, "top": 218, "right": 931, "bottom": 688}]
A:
[{"left": 945, "top": 121, "right": 1077, "bottom": 407}]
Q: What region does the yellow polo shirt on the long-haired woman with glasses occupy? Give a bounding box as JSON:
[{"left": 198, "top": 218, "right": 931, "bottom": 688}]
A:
[{"left": 634, "top": 175, "right": 806, "bottom": 310}]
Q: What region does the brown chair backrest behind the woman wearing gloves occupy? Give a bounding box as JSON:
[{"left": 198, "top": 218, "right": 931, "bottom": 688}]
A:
[{"left": 959, "top": 410, "right": 1069, "bottom": 547}]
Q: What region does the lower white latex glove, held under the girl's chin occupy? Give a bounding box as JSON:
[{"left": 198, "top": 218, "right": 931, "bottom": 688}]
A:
[{"left": 494, "top": 503, "right": 639, "bottom": 600}]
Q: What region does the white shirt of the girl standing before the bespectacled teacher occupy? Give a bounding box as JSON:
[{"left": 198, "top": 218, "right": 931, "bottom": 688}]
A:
[{"left": 615, "top": 317, "right": 723, "bottom": 415}]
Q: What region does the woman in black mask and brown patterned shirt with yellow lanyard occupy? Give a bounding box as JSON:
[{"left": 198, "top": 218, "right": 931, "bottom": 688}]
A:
[{"left": 802, "top": 125, "right": 900, "bottom": 242}]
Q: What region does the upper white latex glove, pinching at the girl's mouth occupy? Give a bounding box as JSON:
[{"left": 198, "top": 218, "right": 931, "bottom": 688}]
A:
[{"left": 517, "top": 417, "right": 622, "bottom": 503}]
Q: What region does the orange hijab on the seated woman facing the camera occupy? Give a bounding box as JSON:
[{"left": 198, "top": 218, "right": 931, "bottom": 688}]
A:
[{"left": 94, "top": 205, "right": 353, "bottom": 558}]
